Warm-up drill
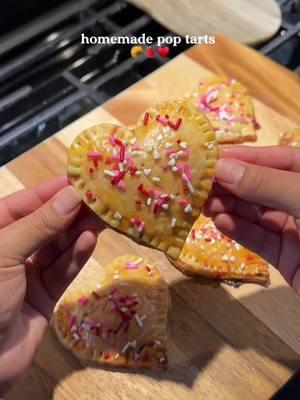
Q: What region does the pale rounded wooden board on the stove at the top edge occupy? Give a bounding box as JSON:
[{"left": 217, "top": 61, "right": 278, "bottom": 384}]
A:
[{"left": 129, "top": 0, "right": 281, "bottom": 44}]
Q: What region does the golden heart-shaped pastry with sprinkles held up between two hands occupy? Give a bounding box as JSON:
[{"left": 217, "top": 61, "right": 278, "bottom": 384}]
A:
[{"left": 68, "top": 100, "right": 217, "bottom": 259}]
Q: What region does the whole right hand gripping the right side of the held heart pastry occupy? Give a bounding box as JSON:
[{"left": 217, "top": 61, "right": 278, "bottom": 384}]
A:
[{"left": 204, "top": 146, "right": 300, "bottom": 294}]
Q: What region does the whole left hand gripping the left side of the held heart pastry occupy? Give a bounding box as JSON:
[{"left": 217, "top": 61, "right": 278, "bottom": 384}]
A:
[{"left": 0, "top": 177, "right": 103, "bottom": 395}]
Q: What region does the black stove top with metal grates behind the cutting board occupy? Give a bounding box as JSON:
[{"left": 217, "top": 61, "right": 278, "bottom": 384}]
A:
[{"left": 0, "top": 0, "right": 300, "bottom": 165}]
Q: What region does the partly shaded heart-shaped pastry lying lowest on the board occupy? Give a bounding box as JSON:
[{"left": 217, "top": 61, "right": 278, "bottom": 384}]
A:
[{"left": 54, "top": 255, "right": 169, "bottom": 369}]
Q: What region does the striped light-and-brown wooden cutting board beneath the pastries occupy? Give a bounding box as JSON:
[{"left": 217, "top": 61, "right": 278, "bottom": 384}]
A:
[{"left": 0, "top": 36, "right": 300, "bottom": 400}]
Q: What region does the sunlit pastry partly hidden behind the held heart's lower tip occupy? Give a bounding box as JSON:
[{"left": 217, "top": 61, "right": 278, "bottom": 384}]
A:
[{"left": 175, "top": 215, "right": 269, "bottom": 284}]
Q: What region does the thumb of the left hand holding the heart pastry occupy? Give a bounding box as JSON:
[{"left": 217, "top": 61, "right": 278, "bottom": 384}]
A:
[{"left": 0, "top": 186, "right": 81, "bottom": 264}]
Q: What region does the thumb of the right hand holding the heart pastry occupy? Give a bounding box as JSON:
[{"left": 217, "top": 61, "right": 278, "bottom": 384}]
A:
[{"left": 216, "top": 158, "right": 300, "bottom": 220}]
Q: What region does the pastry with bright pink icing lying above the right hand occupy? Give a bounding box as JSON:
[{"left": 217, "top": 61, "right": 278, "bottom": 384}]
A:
[{"left": 187, "top": 76, "right": 259, "bottom": 143}]
